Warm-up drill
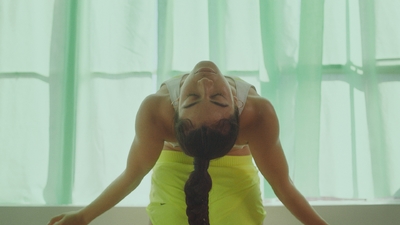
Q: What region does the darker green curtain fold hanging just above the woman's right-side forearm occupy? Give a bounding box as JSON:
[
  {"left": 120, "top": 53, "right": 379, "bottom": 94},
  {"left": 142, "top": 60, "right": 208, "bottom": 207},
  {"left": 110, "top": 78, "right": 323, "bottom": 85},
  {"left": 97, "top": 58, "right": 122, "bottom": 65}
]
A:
[{"left": 293, "top": 0, "right": 324, "bottom": 196}]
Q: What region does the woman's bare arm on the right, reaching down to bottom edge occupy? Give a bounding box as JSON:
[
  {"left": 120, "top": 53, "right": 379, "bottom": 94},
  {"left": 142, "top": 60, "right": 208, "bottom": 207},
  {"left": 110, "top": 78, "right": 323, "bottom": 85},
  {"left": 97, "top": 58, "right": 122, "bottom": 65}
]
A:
[{"left": 246, "top": 98, "right": 327, "bottom": 225}]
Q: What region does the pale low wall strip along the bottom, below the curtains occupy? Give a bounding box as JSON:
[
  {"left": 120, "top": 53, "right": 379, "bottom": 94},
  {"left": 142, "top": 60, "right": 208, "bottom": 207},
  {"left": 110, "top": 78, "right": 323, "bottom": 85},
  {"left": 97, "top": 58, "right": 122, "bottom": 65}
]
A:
[{"left": 0, "top": 204, "right": 400, "bottom": 225}]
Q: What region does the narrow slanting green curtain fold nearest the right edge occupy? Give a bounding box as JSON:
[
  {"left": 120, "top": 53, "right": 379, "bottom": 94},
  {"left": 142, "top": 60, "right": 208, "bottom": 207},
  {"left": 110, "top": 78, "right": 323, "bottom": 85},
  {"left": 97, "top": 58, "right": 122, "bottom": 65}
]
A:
[{"left": 360, "top": 1, "right": 390, "bottom": 197}]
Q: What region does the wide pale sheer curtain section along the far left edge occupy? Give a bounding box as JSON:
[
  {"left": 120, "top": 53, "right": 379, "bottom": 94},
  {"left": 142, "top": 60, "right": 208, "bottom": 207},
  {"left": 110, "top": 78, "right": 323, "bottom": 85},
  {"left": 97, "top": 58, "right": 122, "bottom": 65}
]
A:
[{"left": 0, "top": 0, "right": 54, "bottom": 204}]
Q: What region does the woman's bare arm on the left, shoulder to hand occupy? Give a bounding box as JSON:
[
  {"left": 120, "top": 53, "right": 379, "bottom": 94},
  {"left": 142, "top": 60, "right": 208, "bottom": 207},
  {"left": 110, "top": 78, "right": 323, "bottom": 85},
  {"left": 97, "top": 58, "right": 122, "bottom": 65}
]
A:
[{"left": 49, "top": 96, "right": 164, "bottom": 225}]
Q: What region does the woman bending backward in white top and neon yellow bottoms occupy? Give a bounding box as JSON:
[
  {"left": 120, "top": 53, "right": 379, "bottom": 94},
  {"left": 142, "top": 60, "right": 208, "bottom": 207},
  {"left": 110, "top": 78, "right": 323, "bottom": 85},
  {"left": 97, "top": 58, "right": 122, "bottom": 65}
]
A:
[{"left": 49, "top": 61, "right": 327, "bottom": 225}]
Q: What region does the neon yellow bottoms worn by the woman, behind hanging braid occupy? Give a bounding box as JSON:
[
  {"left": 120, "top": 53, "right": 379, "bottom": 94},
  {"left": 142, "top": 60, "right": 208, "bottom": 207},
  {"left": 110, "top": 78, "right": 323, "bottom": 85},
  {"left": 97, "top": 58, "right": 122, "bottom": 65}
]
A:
[{"left": 147, "top": 150, "right": 265, "bottom": 225}]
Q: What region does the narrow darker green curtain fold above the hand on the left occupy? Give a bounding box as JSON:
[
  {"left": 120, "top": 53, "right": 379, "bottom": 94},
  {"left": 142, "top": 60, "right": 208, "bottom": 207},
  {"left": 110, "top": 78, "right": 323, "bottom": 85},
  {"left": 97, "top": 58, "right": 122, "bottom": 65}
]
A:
[{"left": 44, "top": 1, "right": 79, "bottom": 204}]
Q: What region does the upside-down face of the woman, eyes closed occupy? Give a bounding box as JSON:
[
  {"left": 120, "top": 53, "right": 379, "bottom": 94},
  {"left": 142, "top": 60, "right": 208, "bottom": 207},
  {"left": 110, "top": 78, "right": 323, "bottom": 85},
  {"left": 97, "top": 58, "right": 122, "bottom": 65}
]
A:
[{"left": 178, "top": 61, "right": 234, "bottom": 127}]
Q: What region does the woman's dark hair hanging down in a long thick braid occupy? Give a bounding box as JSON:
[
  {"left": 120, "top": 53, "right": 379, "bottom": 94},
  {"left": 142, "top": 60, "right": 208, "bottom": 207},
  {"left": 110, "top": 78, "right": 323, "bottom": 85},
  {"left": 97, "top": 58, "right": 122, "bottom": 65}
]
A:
[{"left": 174, "top": 108, "right": 239, "bottom": 225}]
